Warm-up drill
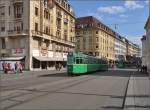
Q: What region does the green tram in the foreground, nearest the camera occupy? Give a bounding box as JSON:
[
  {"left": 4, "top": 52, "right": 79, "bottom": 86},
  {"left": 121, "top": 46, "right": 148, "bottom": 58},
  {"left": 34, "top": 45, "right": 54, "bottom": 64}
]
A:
[{"left": 67, "top": 52, "right": 108, "bottom": 75}]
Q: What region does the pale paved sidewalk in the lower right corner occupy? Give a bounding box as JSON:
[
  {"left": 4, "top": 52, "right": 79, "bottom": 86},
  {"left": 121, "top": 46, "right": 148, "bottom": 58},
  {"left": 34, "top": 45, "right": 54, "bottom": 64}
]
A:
[{"left": 124, "top": 72, "right": 150, "bottom": 110}]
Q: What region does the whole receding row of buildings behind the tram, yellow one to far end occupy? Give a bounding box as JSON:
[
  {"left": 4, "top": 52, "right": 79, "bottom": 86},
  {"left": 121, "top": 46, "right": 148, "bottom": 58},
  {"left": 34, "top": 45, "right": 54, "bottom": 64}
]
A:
[{"left": 76, "top": 16, "right": 141, "bottom": 64}]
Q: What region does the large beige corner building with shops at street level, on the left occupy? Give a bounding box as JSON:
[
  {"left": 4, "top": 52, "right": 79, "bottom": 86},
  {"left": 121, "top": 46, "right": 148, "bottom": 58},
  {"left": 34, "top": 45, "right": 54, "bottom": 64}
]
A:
[{"left": 0, "top": 0, "right": 75, "bottom": 70}]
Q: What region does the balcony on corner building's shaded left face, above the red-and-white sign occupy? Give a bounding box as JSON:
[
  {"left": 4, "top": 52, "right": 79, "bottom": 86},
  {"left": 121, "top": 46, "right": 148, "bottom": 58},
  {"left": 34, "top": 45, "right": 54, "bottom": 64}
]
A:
[{"left": 8, "top": 30, "right": 28, "bottom": 36}]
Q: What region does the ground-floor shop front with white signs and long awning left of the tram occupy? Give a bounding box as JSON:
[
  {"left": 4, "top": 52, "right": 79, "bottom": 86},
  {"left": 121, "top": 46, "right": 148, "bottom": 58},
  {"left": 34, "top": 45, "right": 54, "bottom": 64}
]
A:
[{"left": 32, "top": 50, "right": 67, "bottom": 70}]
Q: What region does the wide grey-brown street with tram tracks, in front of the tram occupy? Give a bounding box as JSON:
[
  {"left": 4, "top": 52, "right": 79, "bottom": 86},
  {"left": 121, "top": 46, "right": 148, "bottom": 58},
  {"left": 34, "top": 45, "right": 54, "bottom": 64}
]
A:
[{"left": 0, "top": 70, "right": 149, "bottom": 110}]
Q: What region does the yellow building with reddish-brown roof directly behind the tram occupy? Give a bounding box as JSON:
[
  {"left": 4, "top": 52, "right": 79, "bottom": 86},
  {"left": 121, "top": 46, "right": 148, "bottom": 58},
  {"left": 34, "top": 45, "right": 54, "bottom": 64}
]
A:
[{"left": 76, "top": 16, "right": 115, "bottom": 62}]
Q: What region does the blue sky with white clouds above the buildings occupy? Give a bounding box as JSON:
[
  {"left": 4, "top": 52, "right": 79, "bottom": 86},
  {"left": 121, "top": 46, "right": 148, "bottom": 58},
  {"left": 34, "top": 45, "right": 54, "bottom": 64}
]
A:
[{"left": 69, "top": 0, "right": 149, "bottom": 46}]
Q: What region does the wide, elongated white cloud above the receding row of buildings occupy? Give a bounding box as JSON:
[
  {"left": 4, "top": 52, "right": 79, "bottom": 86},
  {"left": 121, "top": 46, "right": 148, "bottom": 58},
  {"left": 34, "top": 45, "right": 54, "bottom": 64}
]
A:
[{"left": 97, "top": 6, "right": 126, "bottom": 14}]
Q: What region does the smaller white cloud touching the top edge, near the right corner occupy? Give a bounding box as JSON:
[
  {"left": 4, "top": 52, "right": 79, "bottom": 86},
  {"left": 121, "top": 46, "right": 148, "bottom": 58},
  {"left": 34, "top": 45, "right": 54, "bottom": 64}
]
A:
[{"left": 124, "top": 0, "right": 144, "bottom": 10}]
